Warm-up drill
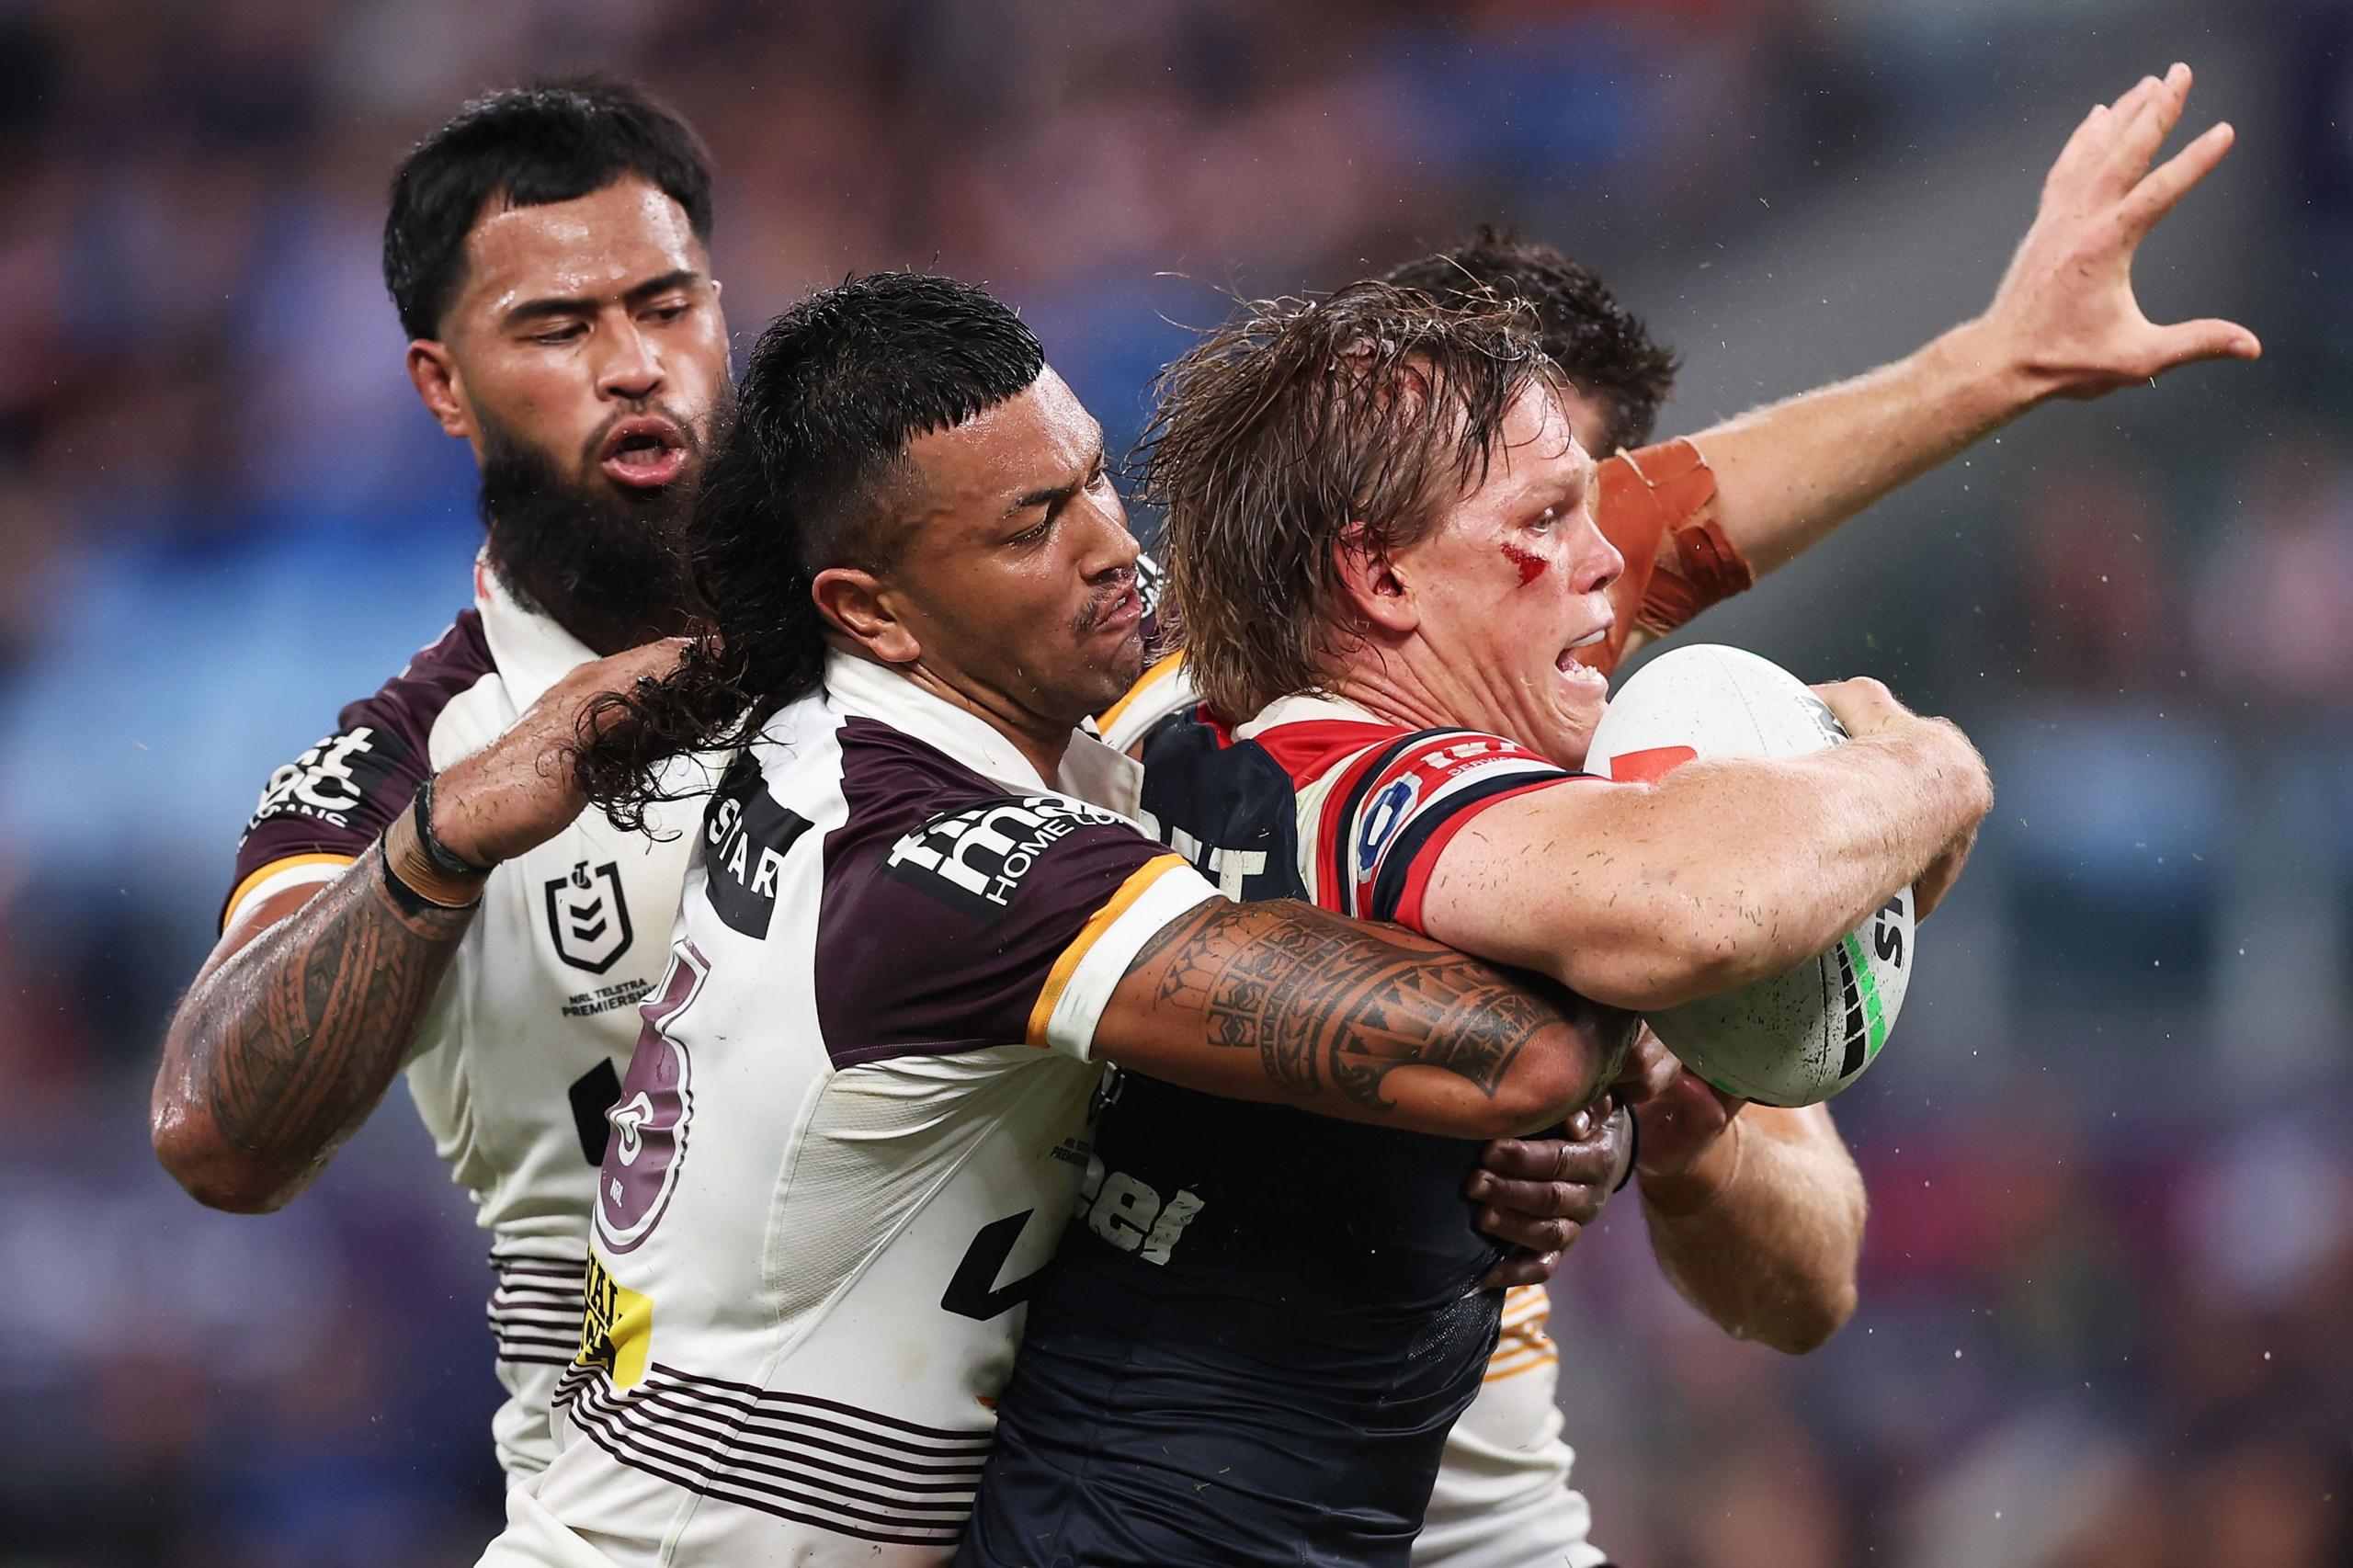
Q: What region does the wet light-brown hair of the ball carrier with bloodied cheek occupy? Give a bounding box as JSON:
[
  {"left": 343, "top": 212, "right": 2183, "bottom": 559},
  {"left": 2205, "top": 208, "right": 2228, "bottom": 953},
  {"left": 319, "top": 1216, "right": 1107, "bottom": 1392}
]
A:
[{"left": 1142, "top": 282, "right": 1560, "bottom": 718}]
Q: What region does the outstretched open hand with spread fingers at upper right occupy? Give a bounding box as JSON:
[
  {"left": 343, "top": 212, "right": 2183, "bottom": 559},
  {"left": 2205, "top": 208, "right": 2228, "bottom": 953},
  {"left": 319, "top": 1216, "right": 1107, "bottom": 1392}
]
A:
[{"left": 1979, "top": 63, "right": 2264, "bottom": 398}]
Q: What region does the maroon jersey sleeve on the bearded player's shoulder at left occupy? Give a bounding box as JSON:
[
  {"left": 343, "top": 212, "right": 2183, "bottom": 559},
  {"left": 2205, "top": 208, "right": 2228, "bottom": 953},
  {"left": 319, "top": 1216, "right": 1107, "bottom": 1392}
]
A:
[{"left": 222, "top": 609, "right": 489, "bottom": 930}]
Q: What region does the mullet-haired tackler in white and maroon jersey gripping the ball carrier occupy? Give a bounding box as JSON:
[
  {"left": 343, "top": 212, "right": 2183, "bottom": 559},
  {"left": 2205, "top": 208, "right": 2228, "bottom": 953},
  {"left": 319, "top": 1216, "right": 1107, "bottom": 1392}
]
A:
[{"left": 484, "top": 273, "right": 1631, "bottom": 1568}]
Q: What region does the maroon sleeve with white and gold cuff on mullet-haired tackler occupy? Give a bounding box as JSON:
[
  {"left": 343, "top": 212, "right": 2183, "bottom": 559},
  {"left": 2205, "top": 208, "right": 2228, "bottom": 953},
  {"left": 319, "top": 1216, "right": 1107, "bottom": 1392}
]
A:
[{"left": 816, "top": 796, "right": 1219, "bottom": 1066}]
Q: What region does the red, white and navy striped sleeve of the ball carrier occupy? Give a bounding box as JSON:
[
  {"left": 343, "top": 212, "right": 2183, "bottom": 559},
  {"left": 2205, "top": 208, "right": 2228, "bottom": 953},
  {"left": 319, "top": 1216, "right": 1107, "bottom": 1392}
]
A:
[{"left": 1318, "top": 730, "right": 1593, "bottom": 935}]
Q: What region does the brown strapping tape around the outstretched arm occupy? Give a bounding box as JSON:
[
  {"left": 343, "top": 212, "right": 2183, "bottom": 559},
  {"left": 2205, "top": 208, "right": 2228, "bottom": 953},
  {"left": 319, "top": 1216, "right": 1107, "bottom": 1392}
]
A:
[{"left": 1579, "top": 440, "right": 1756, "bottom": 671}]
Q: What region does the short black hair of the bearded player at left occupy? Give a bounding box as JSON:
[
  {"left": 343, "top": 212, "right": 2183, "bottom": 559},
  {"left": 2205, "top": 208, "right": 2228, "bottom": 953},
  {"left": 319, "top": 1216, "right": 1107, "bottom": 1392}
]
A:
[{"left": 383, "top": 75, "right": 710, "bottom": 336}]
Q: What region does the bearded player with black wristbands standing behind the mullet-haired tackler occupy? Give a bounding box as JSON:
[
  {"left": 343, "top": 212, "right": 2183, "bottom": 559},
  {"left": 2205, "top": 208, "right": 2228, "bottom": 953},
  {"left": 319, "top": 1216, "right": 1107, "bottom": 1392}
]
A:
[{"left": 153, "top": 80, "right": 1584, "bottom": 1506}]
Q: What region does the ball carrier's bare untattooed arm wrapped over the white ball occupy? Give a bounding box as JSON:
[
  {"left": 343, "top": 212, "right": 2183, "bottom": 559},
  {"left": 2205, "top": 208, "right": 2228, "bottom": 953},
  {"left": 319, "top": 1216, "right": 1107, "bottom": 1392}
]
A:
[{"left": 1421, "top": 680, "right": 1993, "bottom": 1010}]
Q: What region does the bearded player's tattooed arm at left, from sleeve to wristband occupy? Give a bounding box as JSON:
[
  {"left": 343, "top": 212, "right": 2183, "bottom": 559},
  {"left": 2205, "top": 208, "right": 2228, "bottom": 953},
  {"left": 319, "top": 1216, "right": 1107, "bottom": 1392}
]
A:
[{"left": 153, "top": 847, "right": 473, "bottom": 1208}]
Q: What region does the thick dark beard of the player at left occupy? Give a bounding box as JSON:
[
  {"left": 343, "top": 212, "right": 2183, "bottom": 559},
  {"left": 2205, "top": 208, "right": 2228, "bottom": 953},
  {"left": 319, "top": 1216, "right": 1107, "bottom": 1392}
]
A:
[{"left": 475, "top": 412, "right": 701, "bottom": 654}]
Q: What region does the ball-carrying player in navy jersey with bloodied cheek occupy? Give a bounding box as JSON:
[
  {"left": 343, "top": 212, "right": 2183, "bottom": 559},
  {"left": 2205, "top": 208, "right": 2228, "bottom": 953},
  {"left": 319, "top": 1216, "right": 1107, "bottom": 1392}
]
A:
[{"left": 960, "top": 282, "right": 1993, "bottom": 1568}]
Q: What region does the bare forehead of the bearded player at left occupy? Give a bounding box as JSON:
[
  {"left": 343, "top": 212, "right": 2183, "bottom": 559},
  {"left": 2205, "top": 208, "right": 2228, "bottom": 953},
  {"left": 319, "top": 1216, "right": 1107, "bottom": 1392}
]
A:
[{"left": 454, "top": 176, "right": 703, "bottom": 324}]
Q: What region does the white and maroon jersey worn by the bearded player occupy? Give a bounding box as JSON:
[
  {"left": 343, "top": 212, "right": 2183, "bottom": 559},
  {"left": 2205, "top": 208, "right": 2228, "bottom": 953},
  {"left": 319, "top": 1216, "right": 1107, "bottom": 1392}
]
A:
[{"left": 222, "top": 565, "right": 701, "bottom": 1479}]
